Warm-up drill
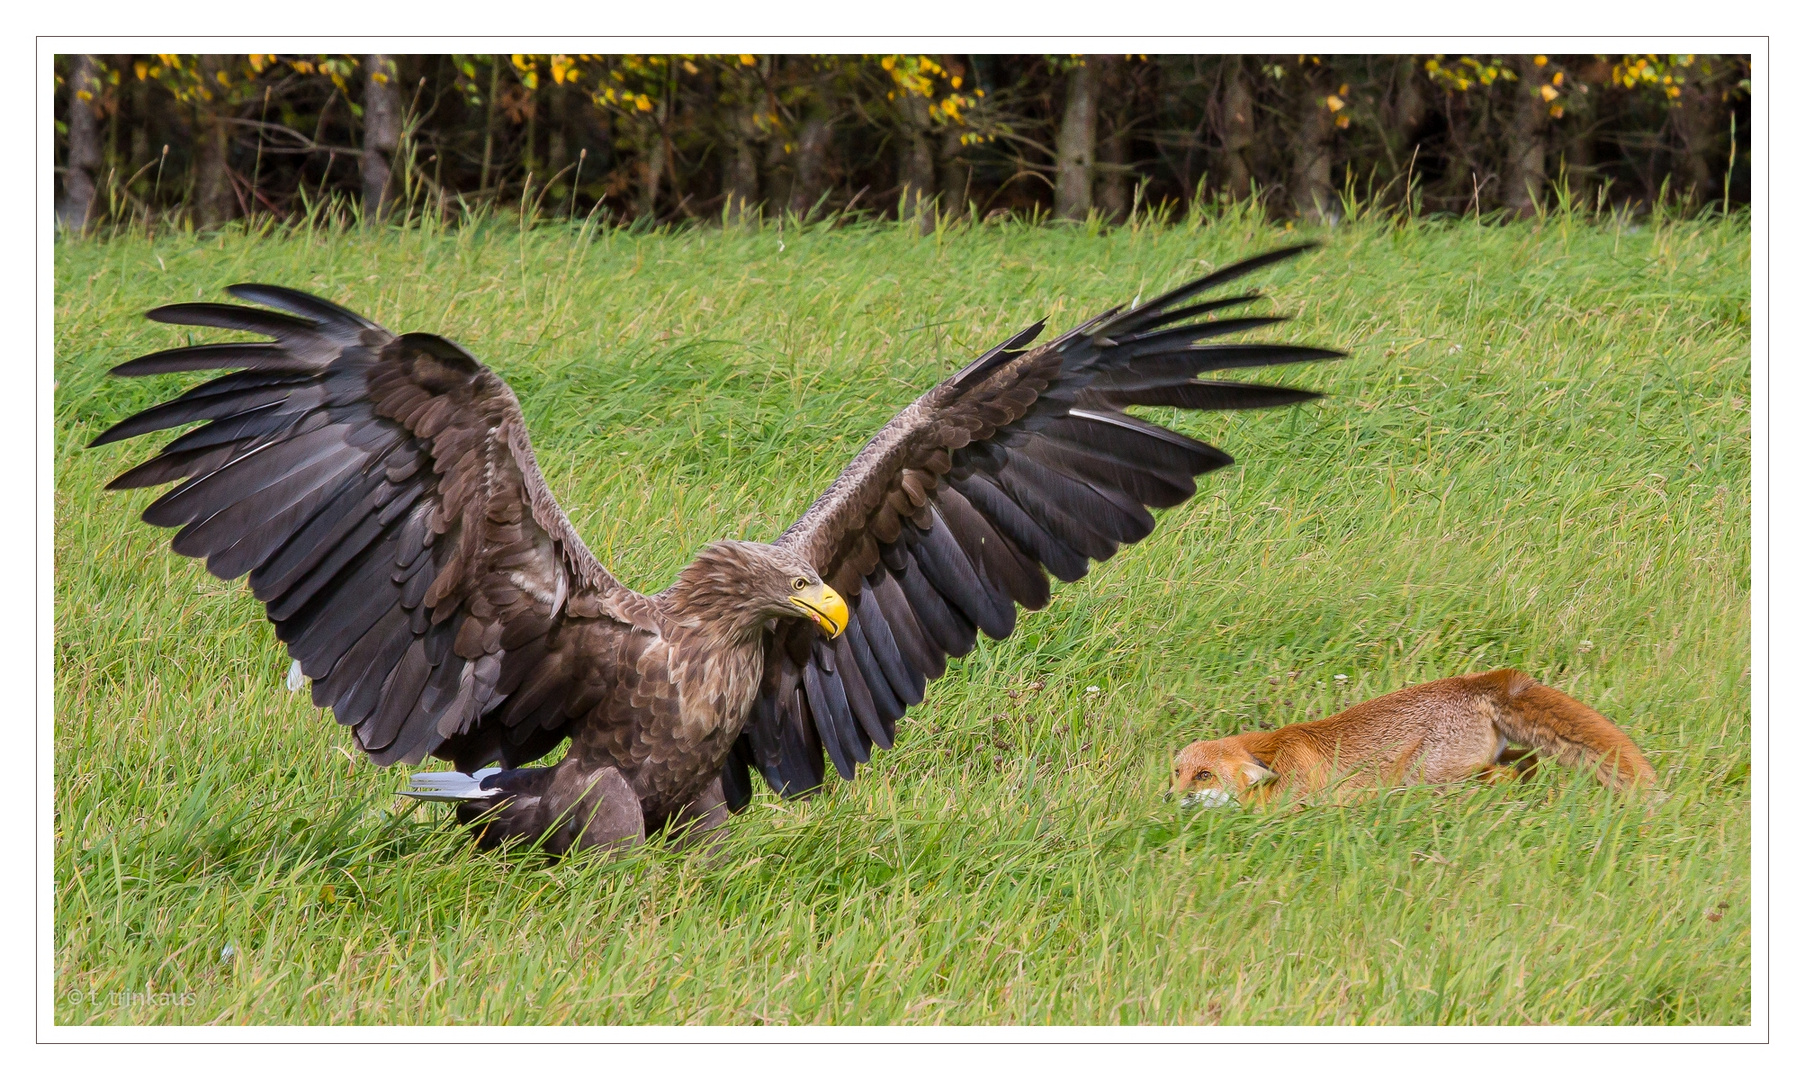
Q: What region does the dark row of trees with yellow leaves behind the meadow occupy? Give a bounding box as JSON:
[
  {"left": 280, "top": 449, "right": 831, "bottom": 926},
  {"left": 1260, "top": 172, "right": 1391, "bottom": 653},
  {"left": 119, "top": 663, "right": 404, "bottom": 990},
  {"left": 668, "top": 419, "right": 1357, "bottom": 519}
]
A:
[{"left": 54, "top": 54, "right": 1749, "bottom": 231}]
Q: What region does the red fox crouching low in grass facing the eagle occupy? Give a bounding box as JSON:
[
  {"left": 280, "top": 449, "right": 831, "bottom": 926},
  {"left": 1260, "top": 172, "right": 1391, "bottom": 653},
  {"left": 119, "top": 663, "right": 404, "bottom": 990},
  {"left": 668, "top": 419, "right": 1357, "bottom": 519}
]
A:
[{"left": 1166, "top": 668, "right": 1655, "bottom": 805}]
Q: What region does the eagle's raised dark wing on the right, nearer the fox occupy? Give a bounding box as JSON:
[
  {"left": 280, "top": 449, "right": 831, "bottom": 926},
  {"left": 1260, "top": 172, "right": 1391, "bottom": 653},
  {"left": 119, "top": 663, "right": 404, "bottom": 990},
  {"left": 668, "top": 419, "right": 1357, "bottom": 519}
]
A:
[{"left": 722, "top": 244, "right": 1343, "bottom": 805}]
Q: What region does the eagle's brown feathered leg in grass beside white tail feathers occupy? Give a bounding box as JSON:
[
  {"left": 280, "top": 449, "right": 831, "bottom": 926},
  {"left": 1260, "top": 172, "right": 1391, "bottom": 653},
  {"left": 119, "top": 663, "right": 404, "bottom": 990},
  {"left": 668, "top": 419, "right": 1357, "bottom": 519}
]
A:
[{"left": 457, "top": 755, "right": 646, "bottom": 854}]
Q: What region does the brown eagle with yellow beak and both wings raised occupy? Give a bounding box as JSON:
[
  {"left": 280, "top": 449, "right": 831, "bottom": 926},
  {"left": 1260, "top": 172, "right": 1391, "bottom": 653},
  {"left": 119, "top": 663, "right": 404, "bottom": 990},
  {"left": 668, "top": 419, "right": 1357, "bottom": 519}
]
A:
[{"left": 90, "top": 244, "right": 1345, "bottom": 854}]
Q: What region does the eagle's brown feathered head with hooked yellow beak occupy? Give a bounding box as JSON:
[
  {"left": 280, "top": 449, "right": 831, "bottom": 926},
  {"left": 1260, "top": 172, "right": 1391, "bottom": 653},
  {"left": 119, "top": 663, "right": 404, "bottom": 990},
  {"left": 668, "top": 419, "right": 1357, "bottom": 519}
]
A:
[{"left": 671, "top": 540, "right": 848, "bottom": 638}]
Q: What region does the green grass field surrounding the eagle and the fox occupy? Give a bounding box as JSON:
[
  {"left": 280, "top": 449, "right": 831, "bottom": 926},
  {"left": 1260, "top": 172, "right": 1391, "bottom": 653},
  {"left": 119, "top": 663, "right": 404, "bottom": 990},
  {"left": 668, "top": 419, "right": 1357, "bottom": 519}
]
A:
[{"left": 54, "top": 209, "right": 1751, "bottom": 1024}]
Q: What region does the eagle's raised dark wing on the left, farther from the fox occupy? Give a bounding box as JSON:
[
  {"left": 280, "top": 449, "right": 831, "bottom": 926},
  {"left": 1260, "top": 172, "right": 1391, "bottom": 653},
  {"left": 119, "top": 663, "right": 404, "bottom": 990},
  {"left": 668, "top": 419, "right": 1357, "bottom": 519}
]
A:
[{"left": 94, "top": 285, "right": 644, "bottom": 769}]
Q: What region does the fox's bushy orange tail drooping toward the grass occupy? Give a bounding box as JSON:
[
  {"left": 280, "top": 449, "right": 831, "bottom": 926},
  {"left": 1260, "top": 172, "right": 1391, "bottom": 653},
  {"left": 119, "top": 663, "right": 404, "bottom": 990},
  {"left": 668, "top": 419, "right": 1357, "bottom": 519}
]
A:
[{"left": 1473, "top": 668, "right": 1655, "bottom": 791}]
